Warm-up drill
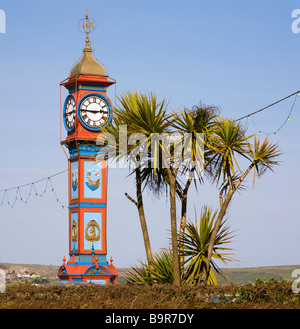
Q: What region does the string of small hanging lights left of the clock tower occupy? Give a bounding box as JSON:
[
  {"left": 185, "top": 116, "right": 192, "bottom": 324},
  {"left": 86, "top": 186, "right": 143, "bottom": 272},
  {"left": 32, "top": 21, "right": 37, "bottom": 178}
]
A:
[{"left": 0, "top": 170, "right": 68, "bottom": 209}]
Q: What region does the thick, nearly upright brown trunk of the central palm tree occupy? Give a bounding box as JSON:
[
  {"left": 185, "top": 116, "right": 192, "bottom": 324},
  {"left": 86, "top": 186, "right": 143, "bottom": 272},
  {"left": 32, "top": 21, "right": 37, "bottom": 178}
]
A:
[{"left": 167, "top": 168, "right": 181, "bottom": 286}]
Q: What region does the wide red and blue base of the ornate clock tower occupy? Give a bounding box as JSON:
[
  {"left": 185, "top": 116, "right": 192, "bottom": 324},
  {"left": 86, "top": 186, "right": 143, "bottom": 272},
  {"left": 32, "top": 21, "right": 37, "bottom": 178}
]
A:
[{"left": 57, "top": 254, "right": 118, "bottom": 285}]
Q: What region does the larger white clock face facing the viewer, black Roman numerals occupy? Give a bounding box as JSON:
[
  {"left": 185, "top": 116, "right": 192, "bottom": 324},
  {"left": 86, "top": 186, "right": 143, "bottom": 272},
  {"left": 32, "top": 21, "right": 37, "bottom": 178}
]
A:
[{"left": 79, "top": 95, "right": 110, "bottom": 129}]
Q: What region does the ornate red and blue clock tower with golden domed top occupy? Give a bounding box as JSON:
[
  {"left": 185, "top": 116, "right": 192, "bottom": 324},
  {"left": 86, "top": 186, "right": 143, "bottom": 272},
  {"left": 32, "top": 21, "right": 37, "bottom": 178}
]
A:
[{"left": 58, "top": 14, "right": 118, "bottom": 284}]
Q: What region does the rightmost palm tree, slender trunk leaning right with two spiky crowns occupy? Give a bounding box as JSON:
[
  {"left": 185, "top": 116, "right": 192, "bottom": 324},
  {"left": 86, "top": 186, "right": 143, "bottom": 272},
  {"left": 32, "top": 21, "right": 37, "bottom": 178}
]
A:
[{"left": 202, "top": 118, "right": 280, "bottom": 282}]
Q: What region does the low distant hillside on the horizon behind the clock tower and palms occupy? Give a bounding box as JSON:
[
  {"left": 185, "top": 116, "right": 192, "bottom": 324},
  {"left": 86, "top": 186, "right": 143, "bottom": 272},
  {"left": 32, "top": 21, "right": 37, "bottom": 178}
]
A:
[{"left": 0, "top": 263, "right": 300, "bottom": 284}]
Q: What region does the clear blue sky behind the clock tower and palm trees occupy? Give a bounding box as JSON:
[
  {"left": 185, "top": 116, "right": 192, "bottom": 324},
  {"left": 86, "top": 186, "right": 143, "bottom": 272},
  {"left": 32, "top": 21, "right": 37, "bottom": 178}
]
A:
[{"left": 0, "top": 0, "right": 300, "bottom": 267}]
